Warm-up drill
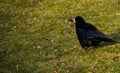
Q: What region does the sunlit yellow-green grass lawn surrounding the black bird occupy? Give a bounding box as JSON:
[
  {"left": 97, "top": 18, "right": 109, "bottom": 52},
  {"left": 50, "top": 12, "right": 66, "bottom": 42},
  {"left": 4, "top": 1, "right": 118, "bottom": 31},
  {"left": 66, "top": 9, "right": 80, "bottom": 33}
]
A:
[{"left": 0, "top": 0, "right": 120, "bottom": 73}]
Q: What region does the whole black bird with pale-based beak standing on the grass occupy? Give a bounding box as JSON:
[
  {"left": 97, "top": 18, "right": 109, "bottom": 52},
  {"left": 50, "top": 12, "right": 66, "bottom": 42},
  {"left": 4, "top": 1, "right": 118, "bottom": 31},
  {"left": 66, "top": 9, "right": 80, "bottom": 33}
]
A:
[{"left": 69, "top": 16, "right": 116, "bottom": 50}]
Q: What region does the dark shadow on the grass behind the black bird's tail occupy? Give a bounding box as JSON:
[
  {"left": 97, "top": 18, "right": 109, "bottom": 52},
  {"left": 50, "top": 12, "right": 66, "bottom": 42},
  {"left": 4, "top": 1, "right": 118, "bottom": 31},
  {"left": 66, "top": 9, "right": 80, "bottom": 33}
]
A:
[{"left": 98, "top": 28, "right": 120, "bottom": 47}]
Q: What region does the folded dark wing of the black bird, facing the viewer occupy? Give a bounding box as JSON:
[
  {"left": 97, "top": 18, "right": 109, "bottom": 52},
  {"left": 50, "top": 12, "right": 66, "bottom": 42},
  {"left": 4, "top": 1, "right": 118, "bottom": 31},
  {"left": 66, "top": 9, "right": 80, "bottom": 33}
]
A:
[{"left": 77, "top": 29, "right": 116, "bottom": 42}]
